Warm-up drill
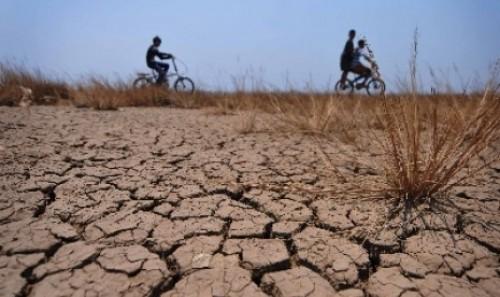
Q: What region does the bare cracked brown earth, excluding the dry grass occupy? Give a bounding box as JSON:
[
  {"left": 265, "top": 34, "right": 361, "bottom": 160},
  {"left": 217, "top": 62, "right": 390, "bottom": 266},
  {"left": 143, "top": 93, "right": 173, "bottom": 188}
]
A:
[{"left": 0, "top": 107, "right": 500, "bottom": 297}]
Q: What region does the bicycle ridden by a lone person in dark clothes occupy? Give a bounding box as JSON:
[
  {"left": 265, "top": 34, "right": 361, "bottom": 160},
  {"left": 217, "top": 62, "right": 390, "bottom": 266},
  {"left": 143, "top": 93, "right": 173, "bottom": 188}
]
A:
[{"left": 133, "top": 57, "right": 195, "bottom": 93}]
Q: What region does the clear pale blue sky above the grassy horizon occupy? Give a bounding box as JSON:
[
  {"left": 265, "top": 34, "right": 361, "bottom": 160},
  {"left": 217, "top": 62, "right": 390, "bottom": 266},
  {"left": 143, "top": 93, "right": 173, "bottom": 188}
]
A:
[{"left": 0, "top": 0, "right": 500, "bottom": 90}]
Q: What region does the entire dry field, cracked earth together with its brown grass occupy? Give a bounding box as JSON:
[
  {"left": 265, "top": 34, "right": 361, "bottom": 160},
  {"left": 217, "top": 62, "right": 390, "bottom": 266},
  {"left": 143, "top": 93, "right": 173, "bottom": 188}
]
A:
[{"left": 0, "top": 63, "right": 500, "bottom": 297}]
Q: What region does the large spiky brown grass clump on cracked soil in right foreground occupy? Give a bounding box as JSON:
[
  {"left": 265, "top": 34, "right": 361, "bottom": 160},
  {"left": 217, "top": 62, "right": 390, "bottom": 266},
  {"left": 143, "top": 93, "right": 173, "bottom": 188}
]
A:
[{"left": 375, "top": 94, "right": 500, "bottom": 230}]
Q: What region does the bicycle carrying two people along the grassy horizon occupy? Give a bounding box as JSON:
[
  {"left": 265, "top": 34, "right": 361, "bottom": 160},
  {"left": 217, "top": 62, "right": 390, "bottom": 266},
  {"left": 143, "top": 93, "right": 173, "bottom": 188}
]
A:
[{"left": 335, "top": 43, "right": 385, "bottom": 96}]
